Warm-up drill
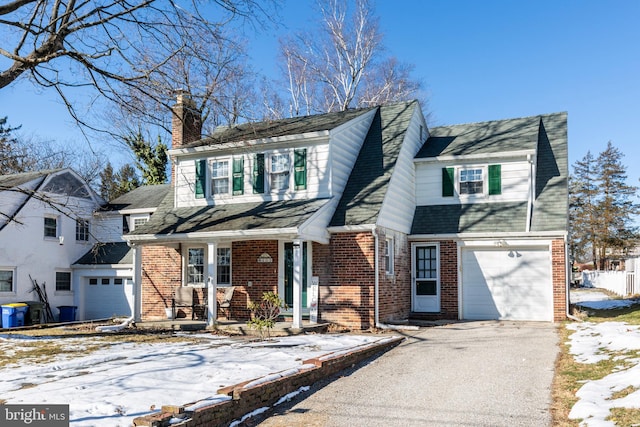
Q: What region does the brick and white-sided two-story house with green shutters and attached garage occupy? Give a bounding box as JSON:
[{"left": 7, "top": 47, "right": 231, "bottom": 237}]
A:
[{"left": 125, "top": 96, "right": 567, "bottom": 329}]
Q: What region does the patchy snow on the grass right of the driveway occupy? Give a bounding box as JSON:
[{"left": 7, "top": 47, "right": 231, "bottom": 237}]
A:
[{"left": 567, "top": 291, "right": 640, "bottom": 427}]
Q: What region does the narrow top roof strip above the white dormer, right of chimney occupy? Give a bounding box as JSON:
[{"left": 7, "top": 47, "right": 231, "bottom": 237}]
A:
[{"left": 182, "top": 108, "right": 372, "bottom": 148}]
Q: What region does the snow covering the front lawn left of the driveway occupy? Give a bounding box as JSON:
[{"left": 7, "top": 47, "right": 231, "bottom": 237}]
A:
[{"left": 0, "top": 334, "right": 389, "bottom": 427}]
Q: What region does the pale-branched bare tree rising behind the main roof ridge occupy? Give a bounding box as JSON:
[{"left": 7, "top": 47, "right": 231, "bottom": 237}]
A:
[{"left": 280, "top": 0, "right": 421, "bottom": 115}]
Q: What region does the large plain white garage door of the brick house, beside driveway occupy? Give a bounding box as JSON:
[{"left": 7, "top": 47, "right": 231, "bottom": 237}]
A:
[{"left": 462, "top": 248, "right": 553, "bottom": 321}]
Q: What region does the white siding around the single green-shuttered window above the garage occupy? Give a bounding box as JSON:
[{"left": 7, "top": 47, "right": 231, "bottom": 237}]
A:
[{"left": 415, "top": 159, "right": 530, "bottom": 206}]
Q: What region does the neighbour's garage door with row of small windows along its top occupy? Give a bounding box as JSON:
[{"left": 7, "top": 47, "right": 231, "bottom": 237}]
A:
[{"left": 84, "top": 277, "right": 131, "bottom": 319}]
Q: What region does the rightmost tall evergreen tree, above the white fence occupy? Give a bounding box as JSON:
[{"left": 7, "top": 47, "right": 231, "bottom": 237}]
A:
[{"left": 597, "top": 141, "right": 640, "bottom": 269}]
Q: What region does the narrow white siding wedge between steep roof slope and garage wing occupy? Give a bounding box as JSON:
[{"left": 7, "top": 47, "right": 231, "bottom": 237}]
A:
[{"left": 378, "top": 107, "right": 427, "bottom": 233}]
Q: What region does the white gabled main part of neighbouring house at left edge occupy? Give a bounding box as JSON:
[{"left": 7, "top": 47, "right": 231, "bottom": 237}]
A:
[{"left": 0, "top": 169, "right": 104, "bottom": 322}]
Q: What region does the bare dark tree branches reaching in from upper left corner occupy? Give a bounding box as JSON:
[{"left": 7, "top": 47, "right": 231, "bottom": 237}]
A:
[{"left": 0, "top": 0, "right": 277, "bottom": 132}]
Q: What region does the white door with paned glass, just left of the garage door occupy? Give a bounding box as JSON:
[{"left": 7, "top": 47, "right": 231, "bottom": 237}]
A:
[{"left": 412, "top": 244, "right": 440, "bottom": 313}]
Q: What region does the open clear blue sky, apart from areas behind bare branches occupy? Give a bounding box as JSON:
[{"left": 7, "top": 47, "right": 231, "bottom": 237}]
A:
[{"left": 0, "top": 0, "right": 640, "bottom": 185}]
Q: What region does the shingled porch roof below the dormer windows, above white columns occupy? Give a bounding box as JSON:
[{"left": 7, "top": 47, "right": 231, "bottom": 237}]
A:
[{"left": 125, "top": 191, "right": 330, "bottom": 242}]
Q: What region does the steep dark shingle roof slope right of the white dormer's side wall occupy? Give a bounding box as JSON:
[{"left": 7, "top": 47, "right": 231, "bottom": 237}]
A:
[{"left": 330, "top": 101, "right": 418, "bottom": 227}]
